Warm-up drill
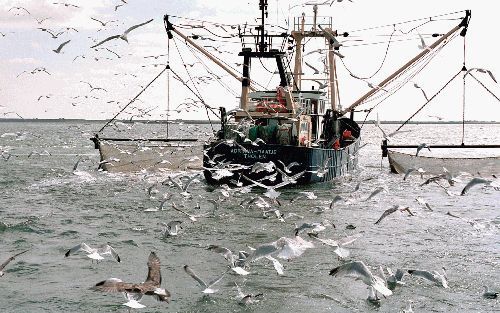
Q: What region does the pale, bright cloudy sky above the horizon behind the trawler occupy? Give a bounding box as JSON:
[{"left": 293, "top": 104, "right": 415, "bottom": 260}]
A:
[{"left": 0, "top": 0, "right": 500, "bottom": 121}]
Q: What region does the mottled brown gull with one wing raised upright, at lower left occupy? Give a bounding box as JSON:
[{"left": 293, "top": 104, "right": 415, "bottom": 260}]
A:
[{"left": 90, "top": 252, "right": 170, "bottom": 303}]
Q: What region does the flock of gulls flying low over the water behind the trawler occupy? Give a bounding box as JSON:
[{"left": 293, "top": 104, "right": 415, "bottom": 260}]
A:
[{"left": 0, "top": 132, "right": 500, "bottom": 312}]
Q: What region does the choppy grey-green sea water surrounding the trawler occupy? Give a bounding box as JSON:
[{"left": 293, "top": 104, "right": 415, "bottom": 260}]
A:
[{"left": 0, "top": 121, "right": 500, "bottom": 312}]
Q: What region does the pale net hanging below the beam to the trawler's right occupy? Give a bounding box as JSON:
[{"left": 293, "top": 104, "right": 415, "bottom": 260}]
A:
[{"left": 387, "top": 150, "right": 500, "bottom": 175}]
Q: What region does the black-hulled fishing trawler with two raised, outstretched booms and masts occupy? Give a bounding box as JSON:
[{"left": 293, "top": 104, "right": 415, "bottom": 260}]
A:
[{"left": 93, "top": 0, "right": 480, "bottom": 182}]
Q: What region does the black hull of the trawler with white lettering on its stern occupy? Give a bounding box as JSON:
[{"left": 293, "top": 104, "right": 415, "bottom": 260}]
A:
[{"left": 203, "top": 138, "right": 359, "bottom": 186}]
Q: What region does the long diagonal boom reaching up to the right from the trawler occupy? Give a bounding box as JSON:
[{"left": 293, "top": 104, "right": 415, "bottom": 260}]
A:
[{"left": 339, "top": 10, "right": 471, "bottom": 116}]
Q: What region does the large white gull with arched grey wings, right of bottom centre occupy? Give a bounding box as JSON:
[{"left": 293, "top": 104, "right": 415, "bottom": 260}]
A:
[{"left": 330, "top": 261, "right": 392, "bottom": 297}]
